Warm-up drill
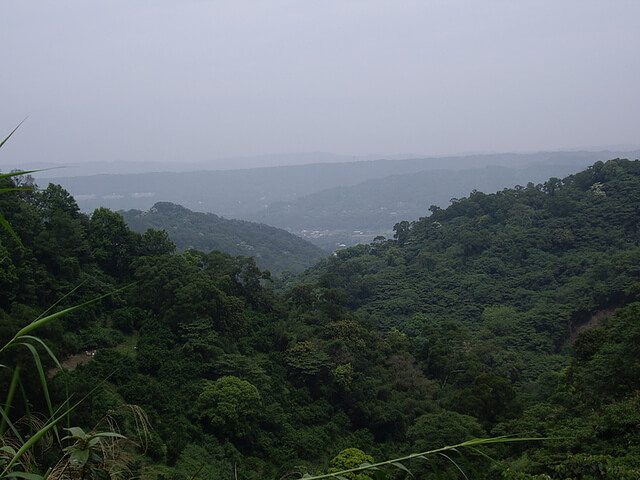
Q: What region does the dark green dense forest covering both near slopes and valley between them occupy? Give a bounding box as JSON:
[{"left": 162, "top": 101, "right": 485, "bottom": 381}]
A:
[{"left": 0, "top": 159, "right": 640, "bottom": 480}]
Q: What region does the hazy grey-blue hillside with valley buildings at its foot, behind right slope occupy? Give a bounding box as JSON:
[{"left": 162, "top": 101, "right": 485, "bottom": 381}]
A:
[{"left": 249, "top": 163, "right": 592, "bottom": 250}]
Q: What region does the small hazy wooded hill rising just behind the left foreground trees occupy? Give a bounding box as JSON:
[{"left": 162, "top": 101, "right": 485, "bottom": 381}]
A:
[{"left": 120, "top": 202, "right": 326, "bottom": 273}]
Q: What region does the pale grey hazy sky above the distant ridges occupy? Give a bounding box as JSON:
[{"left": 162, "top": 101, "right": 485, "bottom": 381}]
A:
[{"left": 0, "top": 0, "right": 640, "bottom": 165}]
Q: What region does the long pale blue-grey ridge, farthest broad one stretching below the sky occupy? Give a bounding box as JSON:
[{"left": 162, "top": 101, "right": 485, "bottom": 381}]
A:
[{"left": 35, "top": 151, "right": 638, "bottom": 219}]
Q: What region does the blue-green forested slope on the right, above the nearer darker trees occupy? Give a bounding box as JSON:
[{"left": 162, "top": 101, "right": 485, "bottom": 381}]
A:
[{"left": 312, "top": 160, "right": 640, "bottom": 353}]
